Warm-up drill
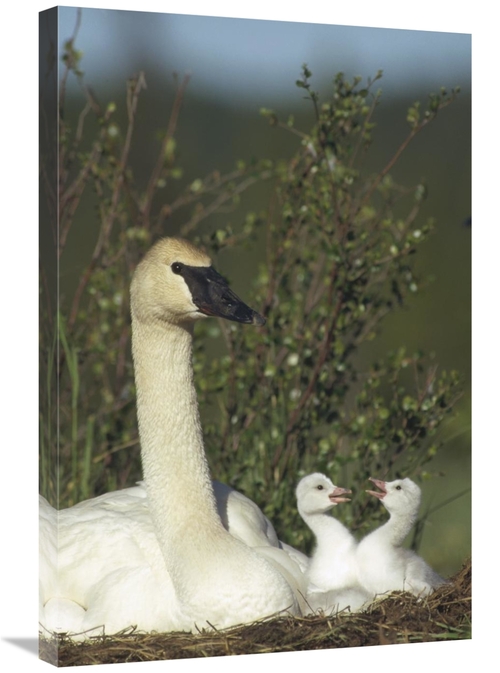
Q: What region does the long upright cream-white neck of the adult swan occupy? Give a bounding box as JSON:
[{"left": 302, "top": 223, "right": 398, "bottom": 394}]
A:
[{"left": 132, "top": 318, "right": 226, "bottom": 584}]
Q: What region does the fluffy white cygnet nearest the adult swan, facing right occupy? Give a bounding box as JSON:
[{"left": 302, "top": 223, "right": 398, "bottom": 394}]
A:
[{"left": 296, "top": 472, "right": 370, "bottom": 612}]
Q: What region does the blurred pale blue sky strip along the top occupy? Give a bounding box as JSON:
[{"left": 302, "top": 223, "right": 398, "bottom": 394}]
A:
[{"left": 59, "top": 7, "right": 471, "bottom": 105}]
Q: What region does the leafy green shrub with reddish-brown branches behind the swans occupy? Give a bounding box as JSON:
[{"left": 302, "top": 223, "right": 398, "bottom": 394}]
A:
[{"left": 40, "top": 40, "right": 460, "bottom": 556}]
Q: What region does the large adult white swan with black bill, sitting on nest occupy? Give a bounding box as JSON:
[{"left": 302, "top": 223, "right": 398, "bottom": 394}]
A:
[{"left": 40, "top": 238, "right": 306, "bottom": 634}]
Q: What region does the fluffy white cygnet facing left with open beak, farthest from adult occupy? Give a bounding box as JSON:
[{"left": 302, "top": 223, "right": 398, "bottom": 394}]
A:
[{"left": 356, "top": 478, "right": 446, "bottom": 598}]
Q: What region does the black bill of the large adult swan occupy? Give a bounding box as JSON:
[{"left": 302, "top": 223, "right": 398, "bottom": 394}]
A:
[{"left": 180, "top": 264, "right": 266, "bottom": 326}]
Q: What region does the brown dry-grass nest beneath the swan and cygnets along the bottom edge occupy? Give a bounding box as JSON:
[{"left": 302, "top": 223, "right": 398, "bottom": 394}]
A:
[{"left": 40, "top": 559, "right": 472, "bottom": 666}]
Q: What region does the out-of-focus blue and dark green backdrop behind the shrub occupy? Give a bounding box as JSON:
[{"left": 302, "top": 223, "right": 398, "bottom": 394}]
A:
[{"left": 52, "top": 8, "right": 471, "bottom": 574}]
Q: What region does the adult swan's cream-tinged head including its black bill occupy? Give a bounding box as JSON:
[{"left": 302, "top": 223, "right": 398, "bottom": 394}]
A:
[{"left": 130, "top": 238, "right": 265, "bottom": 325}]
